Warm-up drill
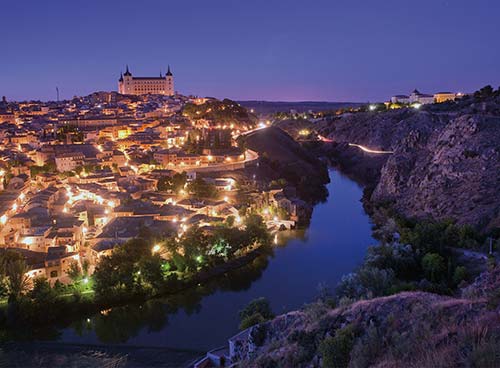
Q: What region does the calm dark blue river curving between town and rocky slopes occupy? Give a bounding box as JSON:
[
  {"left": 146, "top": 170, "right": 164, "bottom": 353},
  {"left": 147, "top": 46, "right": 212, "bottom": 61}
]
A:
[{"left": 59, "top": 170, "right": 375, "bottom": 351}]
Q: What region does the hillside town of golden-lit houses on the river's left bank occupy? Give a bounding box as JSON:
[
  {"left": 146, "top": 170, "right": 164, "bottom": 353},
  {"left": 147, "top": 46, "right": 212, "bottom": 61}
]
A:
[{"left": 0, "top": 82, "right": 302, "bottom": 285}]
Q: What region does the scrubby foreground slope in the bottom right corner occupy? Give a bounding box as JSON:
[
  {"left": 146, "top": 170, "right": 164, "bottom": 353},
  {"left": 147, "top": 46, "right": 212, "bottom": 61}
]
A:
[{"left": 239, "top": 270, "right": 500, "bottom": 367}]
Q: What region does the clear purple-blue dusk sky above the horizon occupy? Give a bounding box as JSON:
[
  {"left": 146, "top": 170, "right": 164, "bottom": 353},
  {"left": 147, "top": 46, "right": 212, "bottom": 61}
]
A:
[{"left": 0, "top": 0, "right": 500, "bottom": 102}]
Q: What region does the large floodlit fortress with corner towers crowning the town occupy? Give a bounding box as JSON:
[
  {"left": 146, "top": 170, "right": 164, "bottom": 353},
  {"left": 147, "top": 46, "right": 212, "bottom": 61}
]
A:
[{"left": 118, "top": 65, "right": 174, "bottom": 96}]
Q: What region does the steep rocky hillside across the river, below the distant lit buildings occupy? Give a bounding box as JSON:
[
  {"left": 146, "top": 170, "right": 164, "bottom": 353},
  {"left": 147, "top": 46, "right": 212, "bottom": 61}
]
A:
[{"left": 320, "top": 105, "right": 500, "bottom": 229}]
